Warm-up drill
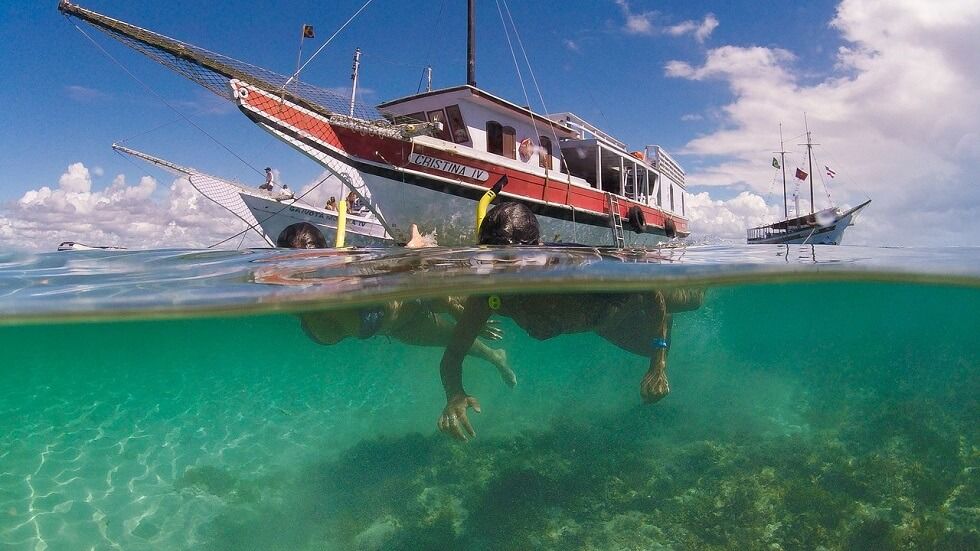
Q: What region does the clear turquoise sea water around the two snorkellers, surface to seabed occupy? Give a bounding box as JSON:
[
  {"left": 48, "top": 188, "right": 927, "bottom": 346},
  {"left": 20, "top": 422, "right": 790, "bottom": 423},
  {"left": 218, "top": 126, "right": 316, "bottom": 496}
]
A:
[{"left": 0, "top": 246, "right": 980, "bottom": 550}]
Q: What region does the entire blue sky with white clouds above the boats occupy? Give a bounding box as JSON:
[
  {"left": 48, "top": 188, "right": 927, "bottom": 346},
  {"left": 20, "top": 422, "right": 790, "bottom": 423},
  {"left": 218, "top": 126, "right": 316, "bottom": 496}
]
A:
[{"left": 0, "top": 0, "right": 980, "bottom": 251}]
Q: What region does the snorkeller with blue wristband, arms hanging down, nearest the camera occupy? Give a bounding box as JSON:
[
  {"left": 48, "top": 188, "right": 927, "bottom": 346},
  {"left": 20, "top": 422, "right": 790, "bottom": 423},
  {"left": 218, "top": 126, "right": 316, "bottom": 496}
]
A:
[{"left": 438, "top": 203, "right": 703, "bottom": 441}]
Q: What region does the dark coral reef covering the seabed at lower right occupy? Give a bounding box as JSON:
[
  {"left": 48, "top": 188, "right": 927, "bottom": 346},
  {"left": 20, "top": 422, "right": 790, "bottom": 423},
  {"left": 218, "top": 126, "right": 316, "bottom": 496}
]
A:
[{"left": 195, "top": 382, "right": 980, "bottom": 550}]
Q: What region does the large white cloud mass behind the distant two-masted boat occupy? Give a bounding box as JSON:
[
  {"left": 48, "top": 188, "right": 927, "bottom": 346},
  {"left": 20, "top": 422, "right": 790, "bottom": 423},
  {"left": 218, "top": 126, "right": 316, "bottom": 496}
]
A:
[{"left": 665, "top": 0, "right": 980, "bottom": 244}]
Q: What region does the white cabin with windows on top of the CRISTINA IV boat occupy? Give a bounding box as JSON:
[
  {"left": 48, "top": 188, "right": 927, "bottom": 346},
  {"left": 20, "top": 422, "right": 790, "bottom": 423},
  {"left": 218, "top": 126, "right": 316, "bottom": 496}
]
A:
[{"left": 378, "top": 85, "right": 687, "bottom": 216}]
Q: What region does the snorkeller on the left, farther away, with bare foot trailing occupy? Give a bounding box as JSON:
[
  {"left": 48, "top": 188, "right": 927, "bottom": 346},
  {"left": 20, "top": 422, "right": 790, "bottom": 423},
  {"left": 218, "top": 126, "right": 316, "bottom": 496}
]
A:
[{"left": 276, "top": 222, "right": 517, "bottom": 387}]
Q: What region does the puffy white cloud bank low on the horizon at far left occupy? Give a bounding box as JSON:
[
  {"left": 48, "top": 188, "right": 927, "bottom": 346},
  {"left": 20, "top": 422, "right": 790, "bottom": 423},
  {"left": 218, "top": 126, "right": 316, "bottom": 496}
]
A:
[{"left": 0, "top": 163, "right": 264, "bottom": 251}]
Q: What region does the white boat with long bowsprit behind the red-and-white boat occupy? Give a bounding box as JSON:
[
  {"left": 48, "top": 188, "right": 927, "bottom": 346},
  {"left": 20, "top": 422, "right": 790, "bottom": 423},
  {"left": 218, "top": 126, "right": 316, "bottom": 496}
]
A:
[{"left": 112, "top": 144, "right": 392, "bottom": 247}]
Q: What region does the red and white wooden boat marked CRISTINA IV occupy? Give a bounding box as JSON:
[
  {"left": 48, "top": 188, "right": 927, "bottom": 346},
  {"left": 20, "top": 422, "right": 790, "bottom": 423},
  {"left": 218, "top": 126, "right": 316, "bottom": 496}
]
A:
[{"left": 59, "top": 0, "right": 689, "bottom": 246}]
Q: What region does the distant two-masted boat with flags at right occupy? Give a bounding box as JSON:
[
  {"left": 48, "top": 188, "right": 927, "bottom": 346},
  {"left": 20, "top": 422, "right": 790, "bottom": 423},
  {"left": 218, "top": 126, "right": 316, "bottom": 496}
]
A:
[{"left": 746, "top": 125, "right": 871, "bottom": 245}]
